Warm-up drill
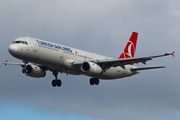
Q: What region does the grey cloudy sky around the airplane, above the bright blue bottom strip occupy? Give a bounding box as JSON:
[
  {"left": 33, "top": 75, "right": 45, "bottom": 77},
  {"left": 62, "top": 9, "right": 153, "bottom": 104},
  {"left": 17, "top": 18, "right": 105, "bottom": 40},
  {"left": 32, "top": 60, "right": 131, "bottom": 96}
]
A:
[{"left": 0, "top": 0, "right": 180, "bottom": 120}]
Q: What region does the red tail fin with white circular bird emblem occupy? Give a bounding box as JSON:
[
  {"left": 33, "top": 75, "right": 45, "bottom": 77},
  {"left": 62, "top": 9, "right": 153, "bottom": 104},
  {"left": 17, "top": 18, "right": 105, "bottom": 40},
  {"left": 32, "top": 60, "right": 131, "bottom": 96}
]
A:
[{"left": 119, "top": 32, "right": 138, "bottom": 59}]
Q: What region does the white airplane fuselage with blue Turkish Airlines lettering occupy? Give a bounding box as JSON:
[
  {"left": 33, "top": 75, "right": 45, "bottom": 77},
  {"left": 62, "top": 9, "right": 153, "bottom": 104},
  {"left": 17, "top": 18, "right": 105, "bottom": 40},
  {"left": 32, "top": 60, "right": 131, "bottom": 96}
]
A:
[{"left": 9, "top": 37, "right": 138, "bottom": 79}]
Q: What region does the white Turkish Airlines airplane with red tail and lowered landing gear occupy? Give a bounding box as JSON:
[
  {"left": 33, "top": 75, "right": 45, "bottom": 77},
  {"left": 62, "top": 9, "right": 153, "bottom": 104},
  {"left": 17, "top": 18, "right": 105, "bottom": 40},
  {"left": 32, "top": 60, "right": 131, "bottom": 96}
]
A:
[{"left": 4, "top": 32, "right": 175, "bottom": 87}]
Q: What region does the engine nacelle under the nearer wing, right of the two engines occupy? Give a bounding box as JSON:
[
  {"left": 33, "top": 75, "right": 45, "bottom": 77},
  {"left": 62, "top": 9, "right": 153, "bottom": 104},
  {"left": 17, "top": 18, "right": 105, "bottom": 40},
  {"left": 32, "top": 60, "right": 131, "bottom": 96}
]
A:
[{"left": 81, "top": 62, "right": 103, "bottom": 75}]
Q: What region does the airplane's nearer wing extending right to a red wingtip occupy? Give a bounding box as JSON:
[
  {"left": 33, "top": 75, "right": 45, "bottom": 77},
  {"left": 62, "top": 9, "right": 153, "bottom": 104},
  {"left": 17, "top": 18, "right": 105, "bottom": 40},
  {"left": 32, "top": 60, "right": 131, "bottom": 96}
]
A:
[{"left": 73, "top": 52, "right": 175, "bottom": 70}]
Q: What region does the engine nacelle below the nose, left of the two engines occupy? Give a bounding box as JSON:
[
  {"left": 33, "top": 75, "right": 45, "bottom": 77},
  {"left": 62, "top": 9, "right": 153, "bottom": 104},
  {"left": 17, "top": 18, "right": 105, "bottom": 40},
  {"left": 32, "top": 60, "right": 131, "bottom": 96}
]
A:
[{"left": 25, "top": 65, "right": 46, "bottom": 78}]
